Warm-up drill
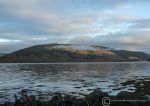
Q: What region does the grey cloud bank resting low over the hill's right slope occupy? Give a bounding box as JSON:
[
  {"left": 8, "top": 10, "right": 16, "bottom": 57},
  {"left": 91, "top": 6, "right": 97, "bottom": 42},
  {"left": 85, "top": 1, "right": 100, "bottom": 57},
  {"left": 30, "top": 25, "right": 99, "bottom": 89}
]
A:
[{"left": 70, "top": 31, "right": 150, "bottom": 53}]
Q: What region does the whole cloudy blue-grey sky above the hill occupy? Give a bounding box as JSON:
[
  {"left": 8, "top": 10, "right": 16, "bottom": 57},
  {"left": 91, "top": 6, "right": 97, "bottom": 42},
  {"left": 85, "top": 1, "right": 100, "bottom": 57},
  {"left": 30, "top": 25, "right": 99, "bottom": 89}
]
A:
[{"left": 0, "top": 0, "right": 150, "bottom": 53}]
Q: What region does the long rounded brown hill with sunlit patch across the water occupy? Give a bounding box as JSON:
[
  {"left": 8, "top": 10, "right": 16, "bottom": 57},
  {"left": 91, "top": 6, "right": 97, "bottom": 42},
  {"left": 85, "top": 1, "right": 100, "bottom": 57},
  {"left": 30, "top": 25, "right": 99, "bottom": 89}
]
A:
[{"left": 0, "top": 44, "right": 150, "bottom": 63}]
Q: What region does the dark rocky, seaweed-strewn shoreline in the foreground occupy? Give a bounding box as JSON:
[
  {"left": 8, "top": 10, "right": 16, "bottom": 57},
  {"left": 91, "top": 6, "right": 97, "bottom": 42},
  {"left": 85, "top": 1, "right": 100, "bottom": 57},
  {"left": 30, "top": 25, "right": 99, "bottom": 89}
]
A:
[{"left": 0, "top": 79, "right": 150, "bottom": 106}]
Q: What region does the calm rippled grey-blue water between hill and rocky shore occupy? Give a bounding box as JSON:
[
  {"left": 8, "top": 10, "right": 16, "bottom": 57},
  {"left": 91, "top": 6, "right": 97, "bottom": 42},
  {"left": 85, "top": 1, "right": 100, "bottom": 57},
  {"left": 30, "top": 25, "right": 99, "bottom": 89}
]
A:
[{"left": 0, "top": 62, "right": 150, "bottom": 102}]
